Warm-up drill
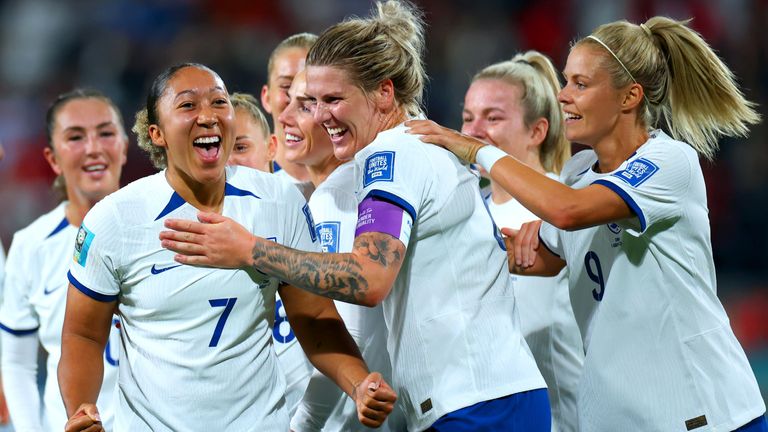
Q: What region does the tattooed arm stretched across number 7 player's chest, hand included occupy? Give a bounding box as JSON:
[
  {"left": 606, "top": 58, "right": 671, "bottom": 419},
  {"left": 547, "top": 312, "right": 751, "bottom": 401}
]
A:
[{"left": 160, "top": 213, "right": 406, "bottom": 306}]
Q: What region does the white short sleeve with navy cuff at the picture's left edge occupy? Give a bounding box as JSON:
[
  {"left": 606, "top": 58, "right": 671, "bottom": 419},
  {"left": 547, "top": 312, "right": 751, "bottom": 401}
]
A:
[{"left": 0, "top": 233, "right": 40, "bottom": 336}]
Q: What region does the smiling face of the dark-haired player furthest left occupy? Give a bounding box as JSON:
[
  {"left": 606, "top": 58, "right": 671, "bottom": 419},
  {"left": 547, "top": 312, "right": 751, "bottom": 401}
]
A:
[{"left": 44, "top": 98, "right": 128, "bottom": 202}]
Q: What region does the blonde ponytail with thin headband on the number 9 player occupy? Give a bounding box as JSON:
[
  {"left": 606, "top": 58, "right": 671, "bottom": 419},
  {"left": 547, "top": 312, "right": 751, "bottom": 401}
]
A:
[{"left": 574, "top": 17, "right": 760, "bottom": 160}]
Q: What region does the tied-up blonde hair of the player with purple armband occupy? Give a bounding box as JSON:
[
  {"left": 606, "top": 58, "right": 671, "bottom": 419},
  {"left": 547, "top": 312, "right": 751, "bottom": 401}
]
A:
[{"left": 307, "top": 0, "right": 427, "bottom": 116}]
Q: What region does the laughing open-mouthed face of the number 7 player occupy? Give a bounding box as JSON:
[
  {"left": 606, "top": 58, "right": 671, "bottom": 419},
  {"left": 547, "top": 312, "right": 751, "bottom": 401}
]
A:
[{"left": 149, "top": 66, "right": 235, "bottom": 185}]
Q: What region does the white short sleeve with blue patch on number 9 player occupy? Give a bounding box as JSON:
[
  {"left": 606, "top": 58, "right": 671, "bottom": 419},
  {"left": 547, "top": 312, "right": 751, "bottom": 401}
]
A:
[{"left": 594, "top": 141, "right": 698, "bottom": 235}]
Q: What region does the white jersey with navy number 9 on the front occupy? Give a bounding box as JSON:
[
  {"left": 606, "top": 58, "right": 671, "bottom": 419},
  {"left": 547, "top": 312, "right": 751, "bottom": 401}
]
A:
[{"left": 540, "top": 131, "right": 765, "bottom": 432}]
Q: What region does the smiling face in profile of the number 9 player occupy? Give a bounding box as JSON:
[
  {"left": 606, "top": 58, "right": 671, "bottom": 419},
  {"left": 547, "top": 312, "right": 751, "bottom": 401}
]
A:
[{"left": 558, "top": 44, "right": 624, "bottom": 148}]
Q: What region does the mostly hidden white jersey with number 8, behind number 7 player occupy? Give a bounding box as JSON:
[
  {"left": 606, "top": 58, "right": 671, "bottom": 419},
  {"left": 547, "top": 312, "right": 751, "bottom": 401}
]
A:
[{"left": 272, "top": 166, "right": 315, "bottom": 417}]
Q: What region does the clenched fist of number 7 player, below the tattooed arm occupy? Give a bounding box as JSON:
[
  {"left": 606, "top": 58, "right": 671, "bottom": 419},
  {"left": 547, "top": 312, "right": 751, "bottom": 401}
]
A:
[{"left": 352, "top": 372, "right": 397, "bottom": 428}]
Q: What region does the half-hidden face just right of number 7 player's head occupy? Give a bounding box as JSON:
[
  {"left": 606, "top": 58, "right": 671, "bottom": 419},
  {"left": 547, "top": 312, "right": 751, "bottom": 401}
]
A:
[{"left": 227, "top": 108, "right": 270, "bottom": 172}]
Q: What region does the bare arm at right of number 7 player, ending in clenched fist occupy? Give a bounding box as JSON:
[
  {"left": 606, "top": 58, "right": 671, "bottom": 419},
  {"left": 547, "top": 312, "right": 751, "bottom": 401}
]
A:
[{"left": 280, "top": 285, "right": 397, "bottom": 427}]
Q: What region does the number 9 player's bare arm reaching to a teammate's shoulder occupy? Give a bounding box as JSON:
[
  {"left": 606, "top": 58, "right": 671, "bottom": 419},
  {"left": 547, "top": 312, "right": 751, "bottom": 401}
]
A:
[{"left": 406, "top": 120, "right": 636, "bottom": 230}]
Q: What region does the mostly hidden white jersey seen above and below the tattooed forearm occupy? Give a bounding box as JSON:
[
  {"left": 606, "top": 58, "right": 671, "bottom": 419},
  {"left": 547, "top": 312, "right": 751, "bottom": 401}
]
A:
[{"left": 291, "top": 162, "right": 405, "bottom": 432}]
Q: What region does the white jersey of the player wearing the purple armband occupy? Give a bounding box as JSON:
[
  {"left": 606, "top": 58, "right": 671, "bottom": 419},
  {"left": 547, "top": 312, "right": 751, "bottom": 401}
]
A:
[{"left": 355, "top": 125, "right": 546, "bottom": 430}]
